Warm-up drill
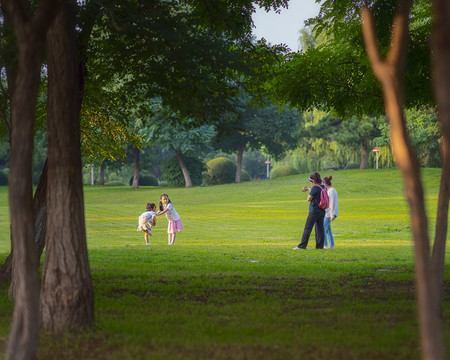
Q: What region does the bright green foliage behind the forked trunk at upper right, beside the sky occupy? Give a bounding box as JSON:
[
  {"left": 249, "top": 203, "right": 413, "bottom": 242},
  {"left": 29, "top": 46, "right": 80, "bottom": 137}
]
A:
[{"left": 267, "top": 0, "right": 433, "bottom": 118}]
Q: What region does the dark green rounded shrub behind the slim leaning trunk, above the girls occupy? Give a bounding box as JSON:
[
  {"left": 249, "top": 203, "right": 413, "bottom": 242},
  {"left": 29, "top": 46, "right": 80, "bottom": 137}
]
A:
[{"left": 161, "top": 155, "right": 206, "bottom": 187}]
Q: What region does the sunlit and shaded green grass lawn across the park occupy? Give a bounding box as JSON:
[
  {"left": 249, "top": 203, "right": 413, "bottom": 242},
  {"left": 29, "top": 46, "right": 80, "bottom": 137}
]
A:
[{"left": 0, "top": 169, "right": 450, "bottom": 360}]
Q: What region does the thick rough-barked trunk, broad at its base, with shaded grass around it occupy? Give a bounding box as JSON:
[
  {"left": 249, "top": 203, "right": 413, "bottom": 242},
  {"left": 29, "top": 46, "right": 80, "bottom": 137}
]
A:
[{"left": 41, "top": 0, "right": 94, "bottom": 332}]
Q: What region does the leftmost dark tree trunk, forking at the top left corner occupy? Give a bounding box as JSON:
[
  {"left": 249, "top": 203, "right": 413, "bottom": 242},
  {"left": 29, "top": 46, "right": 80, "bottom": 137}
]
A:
[{"left": 1, "top": 0, "right": 57, "bottom": 360}]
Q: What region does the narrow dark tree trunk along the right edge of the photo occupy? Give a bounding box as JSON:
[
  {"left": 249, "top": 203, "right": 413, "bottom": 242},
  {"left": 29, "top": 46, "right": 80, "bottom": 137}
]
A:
[{"left": 432, "top": 0, "right": 450, "bottom": 316}]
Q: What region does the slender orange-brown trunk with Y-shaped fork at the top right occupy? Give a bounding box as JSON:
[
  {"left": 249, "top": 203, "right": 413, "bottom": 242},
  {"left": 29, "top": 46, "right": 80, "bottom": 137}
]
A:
[{"left": 362, "top": 0, "right": 444, "bottom": 360}]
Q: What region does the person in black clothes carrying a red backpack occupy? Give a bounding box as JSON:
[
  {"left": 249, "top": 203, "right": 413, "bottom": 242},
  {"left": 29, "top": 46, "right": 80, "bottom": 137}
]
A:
[{"left": 293, "top": 172, "right": 325, "bottom": 250}]
